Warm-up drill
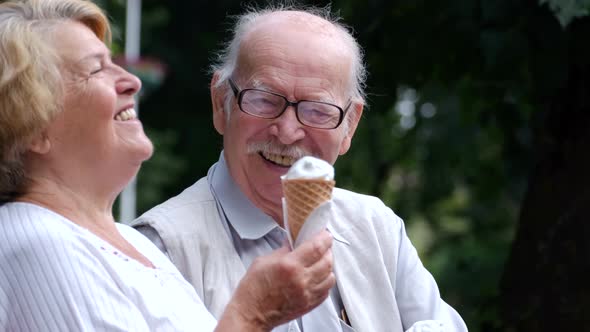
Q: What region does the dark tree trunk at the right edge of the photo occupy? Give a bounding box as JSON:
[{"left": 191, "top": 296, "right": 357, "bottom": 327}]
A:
[{"left": 500, "top": 17, "right": 590, "bottom": 331}]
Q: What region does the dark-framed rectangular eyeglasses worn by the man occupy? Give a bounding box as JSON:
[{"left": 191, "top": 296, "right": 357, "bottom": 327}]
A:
[{"left": 229, "top": 79, "right": 352, "bottom": 129}]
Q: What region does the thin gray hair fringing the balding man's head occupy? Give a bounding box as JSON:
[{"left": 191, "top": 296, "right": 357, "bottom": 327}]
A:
[{"left": 211, "top": 2, "right": 367, "bottom": 110}]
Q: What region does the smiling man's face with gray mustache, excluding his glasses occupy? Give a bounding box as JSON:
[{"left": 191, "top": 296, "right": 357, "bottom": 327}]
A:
[{"left": 213, "top": 15, "right": 362, "bottom": 224}]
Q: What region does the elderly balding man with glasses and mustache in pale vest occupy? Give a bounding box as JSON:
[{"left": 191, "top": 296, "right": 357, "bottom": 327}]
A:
[{"left": 134, "top": 4, "right": 466, "bottom": 332}]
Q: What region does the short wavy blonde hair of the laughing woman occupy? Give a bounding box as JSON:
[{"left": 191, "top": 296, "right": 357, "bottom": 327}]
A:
[{"left": 0, "top": 0, "right": 111, "bottom": 204}]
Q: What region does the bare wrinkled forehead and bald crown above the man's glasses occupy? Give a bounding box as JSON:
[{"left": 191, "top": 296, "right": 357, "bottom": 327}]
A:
[{"left": 234, "top": 12, "right": 351, "bottom": 102}]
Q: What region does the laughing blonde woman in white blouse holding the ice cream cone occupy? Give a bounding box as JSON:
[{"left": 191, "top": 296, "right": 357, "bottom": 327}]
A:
[{"left": 0, "top": 0, "right": 334, "bottom": 331}]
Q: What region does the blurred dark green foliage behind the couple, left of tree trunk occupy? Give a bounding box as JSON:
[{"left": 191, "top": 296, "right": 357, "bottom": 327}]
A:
[{"left": 103, "top": 0, "right": 590, "bottom": 331}]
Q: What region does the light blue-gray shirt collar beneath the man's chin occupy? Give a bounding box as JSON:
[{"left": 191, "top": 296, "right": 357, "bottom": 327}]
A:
[{"left": 207, "top": 151, "right": 279, "bottom": 240}]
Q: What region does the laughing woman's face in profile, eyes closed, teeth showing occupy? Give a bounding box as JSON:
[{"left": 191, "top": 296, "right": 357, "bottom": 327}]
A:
[{"left": 47, "top": 22, "right": 153, "bottom": 195}]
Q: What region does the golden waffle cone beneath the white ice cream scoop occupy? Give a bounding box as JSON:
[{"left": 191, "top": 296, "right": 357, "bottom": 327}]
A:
[{"left": 283, "top": 179, "right": 335, "bottom": 241}]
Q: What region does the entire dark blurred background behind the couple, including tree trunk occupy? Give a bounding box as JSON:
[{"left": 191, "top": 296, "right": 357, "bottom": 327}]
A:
[{"left": 102, "top": 0, "right": 590, "bottom": 331}]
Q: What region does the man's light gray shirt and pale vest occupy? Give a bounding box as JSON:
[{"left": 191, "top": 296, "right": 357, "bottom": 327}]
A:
[{"left": 133, "top": 154, "right": 467, "bottom": 332}]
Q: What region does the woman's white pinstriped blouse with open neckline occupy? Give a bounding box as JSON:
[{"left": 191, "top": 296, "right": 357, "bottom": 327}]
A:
[{"left": 0, "top": 203, "right": 216, "bottom": 332}]
